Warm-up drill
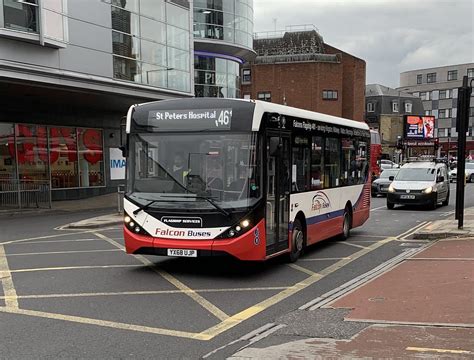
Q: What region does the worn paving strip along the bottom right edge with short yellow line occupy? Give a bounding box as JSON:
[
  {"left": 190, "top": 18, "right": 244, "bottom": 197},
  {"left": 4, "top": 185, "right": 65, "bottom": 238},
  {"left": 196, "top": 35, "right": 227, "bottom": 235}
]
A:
[{"left": 229, "top": 325, "right": 474, "bottom": 360}]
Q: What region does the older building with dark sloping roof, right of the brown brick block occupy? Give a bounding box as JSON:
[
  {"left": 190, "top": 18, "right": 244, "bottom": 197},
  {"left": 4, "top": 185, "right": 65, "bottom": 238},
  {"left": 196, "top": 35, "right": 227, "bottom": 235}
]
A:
[{"left": 365, "top": 84, "right": 424, "bottom": 160}]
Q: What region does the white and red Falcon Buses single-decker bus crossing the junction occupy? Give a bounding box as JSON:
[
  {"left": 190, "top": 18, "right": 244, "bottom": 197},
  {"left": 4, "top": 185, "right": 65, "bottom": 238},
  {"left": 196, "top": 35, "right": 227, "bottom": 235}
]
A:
[{"left": 124, "top": 98, "right": 370, "bottom": 261}]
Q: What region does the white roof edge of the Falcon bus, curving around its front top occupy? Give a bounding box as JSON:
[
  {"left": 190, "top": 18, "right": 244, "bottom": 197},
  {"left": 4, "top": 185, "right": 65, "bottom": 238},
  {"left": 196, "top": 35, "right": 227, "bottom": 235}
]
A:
[{"left": 127, "top": 98, "right": 369, "bottom": 132}]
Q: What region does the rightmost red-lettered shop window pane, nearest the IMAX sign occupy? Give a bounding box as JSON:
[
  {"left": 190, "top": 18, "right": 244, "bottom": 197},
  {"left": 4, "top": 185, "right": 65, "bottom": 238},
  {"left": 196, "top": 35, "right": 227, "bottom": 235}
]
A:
[{"left": 77, "top": 129, "right": 104, "bottom": 187}]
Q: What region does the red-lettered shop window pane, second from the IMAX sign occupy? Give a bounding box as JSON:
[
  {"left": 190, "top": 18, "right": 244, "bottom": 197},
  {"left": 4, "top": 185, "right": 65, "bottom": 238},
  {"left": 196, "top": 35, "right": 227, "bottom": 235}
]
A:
[{"left": 49, "top": 127, "right": 79, "bottom": 188}]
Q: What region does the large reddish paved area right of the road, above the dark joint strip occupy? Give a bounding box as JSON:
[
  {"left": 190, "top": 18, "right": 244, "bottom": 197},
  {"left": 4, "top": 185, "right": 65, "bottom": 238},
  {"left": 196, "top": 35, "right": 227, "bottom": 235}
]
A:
[{"left": 331, "top": 240, "right": 474, "bottom": 326}]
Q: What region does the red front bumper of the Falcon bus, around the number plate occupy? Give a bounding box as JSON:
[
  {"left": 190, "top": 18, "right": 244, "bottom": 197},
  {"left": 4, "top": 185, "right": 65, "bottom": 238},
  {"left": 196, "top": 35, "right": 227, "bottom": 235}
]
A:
[{"left": 123, "top": 220, "right": 266, "bottom": 261}]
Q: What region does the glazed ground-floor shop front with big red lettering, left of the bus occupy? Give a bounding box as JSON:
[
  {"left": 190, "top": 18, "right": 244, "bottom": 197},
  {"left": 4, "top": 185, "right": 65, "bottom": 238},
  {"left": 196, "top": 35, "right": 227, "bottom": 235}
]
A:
[{"left": 0, "top": 123, "right": 106, "bottom": 208}]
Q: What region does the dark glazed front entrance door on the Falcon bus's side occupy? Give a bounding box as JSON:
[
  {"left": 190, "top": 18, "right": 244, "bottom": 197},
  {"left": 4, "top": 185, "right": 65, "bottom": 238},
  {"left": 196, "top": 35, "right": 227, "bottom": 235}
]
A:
[{"left": 265, "top": 133, "right": 291, "bottom": 256}]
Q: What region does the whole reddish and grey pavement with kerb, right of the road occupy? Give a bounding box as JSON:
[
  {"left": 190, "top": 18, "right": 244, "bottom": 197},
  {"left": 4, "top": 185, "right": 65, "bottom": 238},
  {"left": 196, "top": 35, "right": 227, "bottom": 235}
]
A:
[{"left": 230, "top": 208, "right": 474, "bottom": 360}]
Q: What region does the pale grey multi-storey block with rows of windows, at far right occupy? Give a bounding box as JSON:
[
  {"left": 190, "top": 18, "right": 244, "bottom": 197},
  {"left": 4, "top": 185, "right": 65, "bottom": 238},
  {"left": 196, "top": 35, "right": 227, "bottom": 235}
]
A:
[{"left": 399, "top": 63, "right": 474, "bottom": 156}]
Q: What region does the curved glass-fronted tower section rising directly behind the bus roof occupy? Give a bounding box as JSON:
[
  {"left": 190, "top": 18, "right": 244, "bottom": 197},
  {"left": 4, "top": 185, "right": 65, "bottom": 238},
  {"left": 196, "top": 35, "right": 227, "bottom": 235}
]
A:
[{"left": 193, "top": 0, "right": 255, "bottom": 98}]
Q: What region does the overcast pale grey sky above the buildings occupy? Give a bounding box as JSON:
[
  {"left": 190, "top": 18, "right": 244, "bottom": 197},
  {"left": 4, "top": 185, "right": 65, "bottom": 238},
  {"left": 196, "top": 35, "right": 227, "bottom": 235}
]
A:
[{"left": 254, "top": 0, "right": 474, "bottom": 87}]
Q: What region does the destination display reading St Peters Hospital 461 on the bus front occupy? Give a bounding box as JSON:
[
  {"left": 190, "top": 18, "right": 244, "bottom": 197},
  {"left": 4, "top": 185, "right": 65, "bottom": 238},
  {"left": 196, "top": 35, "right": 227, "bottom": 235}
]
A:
[{"left": 148, "top": 108, "right": 232, "bottom": 131}]
